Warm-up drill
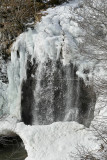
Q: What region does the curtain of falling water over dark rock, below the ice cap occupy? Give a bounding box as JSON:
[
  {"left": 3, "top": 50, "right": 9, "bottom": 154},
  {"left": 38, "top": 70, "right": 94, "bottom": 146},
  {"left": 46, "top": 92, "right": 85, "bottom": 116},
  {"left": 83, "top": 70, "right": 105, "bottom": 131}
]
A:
[{"left": 21, "top": 56, "right": 95, "bottom": 126}]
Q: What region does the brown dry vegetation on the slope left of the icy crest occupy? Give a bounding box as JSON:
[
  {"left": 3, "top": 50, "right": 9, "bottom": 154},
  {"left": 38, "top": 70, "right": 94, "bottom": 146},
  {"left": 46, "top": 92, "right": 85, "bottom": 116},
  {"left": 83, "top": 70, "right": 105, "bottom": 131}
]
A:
[{"left": 0, "top": 0, "right": 64, "bottom": 58}]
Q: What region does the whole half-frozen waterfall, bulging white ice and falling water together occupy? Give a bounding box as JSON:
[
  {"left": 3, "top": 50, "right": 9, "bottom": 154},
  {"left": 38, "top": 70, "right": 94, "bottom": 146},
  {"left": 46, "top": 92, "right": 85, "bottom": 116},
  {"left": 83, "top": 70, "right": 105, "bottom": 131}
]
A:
[{"left": 5, "top": 0, "right": 96, "bottom": 126}]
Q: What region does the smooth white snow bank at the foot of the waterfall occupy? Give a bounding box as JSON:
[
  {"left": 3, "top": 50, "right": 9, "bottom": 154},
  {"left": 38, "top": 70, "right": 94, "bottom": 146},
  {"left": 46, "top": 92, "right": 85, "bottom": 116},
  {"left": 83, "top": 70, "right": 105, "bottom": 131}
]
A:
[{"left": 0, "top": 118, "right": 100, "bottom": 160}]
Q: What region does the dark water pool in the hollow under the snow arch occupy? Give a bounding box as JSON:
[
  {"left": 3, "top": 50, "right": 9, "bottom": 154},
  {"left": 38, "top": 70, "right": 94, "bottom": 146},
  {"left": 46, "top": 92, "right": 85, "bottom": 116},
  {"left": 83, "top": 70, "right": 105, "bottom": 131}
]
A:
[{"left": 0, "top": 136, "right": 27, "bottom": 160}]
